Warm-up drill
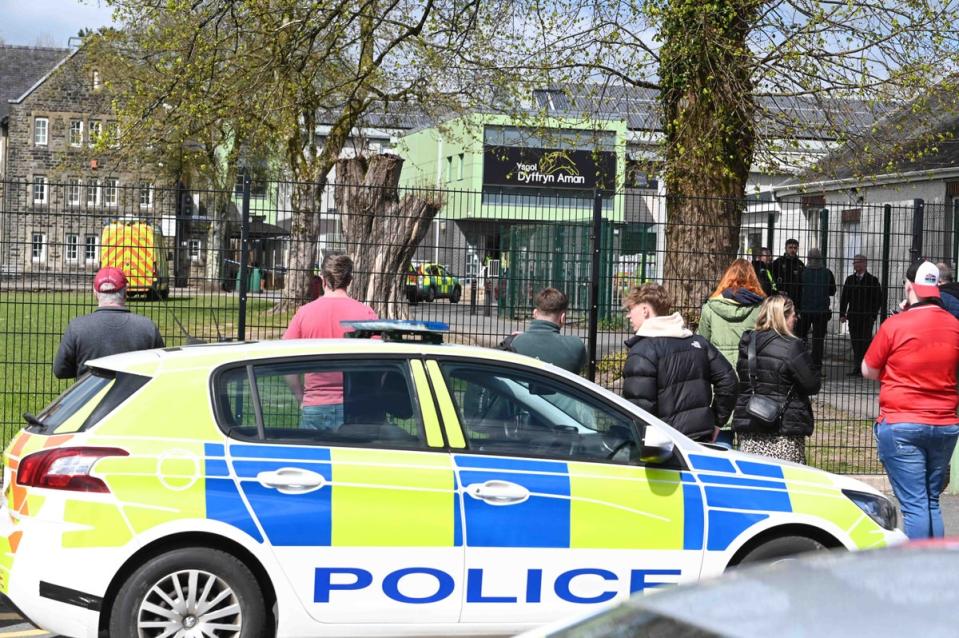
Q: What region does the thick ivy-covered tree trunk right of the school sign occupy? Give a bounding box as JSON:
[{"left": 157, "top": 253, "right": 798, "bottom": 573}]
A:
[{"left": 660, "top": 0, "right": 759, "bottom": 323}]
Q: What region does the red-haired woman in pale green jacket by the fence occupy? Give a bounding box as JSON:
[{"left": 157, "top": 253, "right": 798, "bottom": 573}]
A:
[{"left": 698, "top": 259, "right": 765, "bottom": 447}]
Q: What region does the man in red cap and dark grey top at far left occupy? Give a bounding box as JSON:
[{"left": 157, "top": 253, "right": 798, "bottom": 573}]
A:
[{"left": 53, "top": 268, "right": 163, "bottom": 379}]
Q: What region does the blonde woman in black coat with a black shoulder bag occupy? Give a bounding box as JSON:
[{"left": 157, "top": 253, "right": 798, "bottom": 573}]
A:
[{"left": 733, "top": 295, "right": 820, "bottom": 463}]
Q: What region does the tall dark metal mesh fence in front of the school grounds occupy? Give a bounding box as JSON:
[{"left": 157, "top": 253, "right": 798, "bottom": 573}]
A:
[{"left": 0, "top": 179, "right": 944, "bottom": 473}]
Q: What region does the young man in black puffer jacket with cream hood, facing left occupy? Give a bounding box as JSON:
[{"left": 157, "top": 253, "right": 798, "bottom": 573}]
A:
[{"left": 623, "top": 284, "right": 737, "bottom": 442}]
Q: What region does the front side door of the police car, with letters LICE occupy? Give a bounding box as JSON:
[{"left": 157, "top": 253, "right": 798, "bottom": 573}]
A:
[{"left": 434, "top": 361, "right": 703, "bottom": 623}]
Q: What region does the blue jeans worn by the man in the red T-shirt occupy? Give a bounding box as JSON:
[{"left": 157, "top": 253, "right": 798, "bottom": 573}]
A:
[{"left": 873, "top": 423, "right": 959, "bottom": 538}]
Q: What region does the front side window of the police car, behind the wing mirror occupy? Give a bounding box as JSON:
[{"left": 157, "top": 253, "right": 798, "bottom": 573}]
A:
[{"left": 440, "top": 363, "right": 638, "bottom": 463}]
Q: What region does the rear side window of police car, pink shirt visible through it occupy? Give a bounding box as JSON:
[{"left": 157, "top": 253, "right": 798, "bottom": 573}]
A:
[{"left": 216, "top": 361, "right": 426, "bottom": 448}]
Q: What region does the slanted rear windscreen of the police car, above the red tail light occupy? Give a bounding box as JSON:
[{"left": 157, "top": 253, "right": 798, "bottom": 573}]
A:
[{"left": 31, "top": 369, "right": 150, "bottom": 434}]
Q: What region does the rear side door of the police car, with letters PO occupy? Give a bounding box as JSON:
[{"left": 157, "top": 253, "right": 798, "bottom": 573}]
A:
[{"left": 215, "top": 358, "right": 463, "bottom": 624}]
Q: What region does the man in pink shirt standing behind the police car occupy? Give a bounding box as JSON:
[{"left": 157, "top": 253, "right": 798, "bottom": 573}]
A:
[{"left": 283, "top": 255, "right": 378, "bottom": 430}]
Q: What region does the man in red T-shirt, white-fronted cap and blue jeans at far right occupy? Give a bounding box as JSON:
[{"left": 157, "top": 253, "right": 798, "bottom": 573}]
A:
[{"left": 862, "top": 261, "right": 959, "bottom": 538}]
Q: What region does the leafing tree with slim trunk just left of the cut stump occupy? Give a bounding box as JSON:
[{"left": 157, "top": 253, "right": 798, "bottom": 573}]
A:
[{"left": 97, "top": 0, "right": 502, "bottom": 310}]
